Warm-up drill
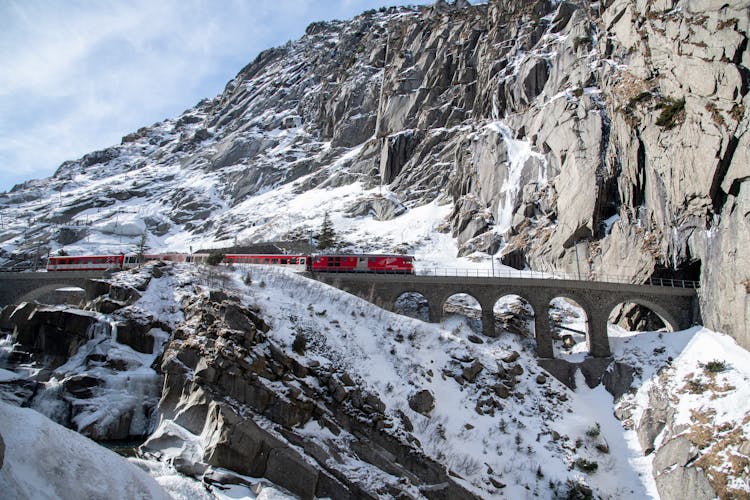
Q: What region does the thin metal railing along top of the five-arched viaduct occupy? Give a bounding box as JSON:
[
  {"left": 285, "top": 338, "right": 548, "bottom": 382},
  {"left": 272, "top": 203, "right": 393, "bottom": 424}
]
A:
[{"left": 415, "top": 267, "right": 700, "bottom": 289}]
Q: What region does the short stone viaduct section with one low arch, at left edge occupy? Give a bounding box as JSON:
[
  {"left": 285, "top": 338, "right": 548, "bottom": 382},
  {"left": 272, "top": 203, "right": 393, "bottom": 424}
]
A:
[{"left": 0, "top": 271, "right": 104, "bottom": 307}]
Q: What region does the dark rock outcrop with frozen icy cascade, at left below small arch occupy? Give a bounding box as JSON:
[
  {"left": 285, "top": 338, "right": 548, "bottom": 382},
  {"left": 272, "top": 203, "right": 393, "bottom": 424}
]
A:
[{"left": 0, "top": 267, "right": 171, "bottom": 441}]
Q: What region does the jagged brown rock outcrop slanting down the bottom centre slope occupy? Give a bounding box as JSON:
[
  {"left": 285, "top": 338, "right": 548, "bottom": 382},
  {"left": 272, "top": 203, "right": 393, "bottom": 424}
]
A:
[{"left": 143, "top": 292, "right": 482, "bottom": 498}]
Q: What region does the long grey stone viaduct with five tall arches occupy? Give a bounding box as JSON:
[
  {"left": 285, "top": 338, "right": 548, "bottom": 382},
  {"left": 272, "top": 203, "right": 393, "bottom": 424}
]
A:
[{"left": 307, "top": 273, "right": 699, "bottom": 358}]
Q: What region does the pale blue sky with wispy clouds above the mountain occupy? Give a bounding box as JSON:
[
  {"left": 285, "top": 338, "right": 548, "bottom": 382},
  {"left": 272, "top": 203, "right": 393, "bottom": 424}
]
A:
[{"left": 0, "top": 0, "right": 446, "bottom": 191}]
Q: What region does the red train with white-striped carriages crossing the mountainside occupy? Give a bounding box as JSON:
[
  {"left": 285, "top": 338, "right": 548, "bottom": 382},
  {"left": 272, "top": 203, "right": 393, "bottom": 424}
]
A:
[{"left": 47, "top": 253, "right": 414, "bottom": 274}]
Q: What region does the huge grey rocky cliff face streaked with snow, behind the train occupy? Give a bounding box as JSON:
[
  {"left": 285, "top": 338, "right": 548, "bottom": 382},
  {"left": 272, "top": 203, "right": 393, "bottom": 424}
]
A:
[{"left": 2, "top": 0, "right": 750, "bottom": 347}]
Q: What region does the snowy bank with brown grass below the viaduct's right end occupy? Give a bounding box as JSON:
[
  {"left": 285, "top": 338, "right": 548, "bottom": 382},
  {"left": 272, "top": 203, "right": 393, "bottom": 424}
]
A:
[{"left": 610, "top": 326, "right": 750, "bottom": 498}]
